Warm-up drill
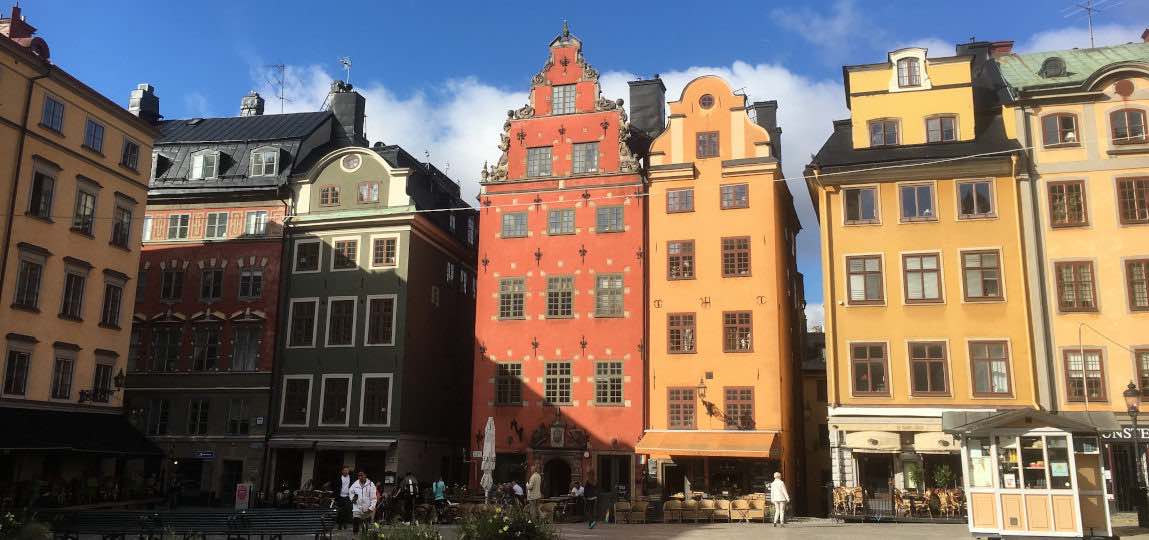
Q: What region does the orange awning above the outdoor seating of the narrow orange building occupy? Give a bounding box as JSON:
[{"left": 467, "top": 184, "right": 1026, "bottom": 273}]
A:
[{"left": 634, "top": 431, "right": 781, "bottom": 458}]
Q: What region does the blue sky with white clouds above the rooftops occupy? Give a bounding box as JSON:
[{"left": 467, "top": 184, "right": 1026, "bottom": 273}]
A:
[{"left": 21, "top": 0, "right": 1149, "bottom": 322}]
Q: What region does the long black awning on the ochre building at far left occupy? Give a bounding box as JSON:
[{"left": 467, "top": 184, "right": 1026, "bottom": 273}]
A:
[{"left": 0, "top": 407, "right": 163, "bottom": 456}]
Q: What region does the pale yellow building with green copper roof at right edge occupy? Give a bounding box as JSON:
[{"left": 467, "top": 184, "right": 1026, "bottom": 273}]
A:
[{"left": 996, "top": 39, "right": 1149, "bottom": 511}]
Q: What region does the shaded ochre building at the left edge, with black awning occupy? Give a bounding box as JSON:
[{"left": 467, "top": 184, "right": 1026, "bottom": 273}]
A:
[{"left": 0, "top": 7, "right": 155, "bottom": 504}]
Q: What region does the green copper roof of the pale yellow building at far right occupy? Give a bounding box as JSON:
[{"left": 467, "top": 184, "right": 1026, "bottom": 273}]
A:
[{"left": 996, "top": 43, "right": 1149, "bottom": 90}]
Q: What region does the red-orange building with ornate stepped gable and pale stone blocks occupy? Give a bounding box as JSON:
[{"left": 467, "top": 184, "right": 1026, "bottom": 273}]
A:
[{"left": 472, "top": 26, "right": 662, "bottom": 494}]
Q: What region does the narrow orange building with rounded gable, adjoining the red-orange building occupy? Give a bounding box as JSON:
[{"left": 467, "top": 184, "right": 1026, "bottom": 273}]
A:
[{"left": 638, "top": 76, "right": 802, "bottom": 497}]
